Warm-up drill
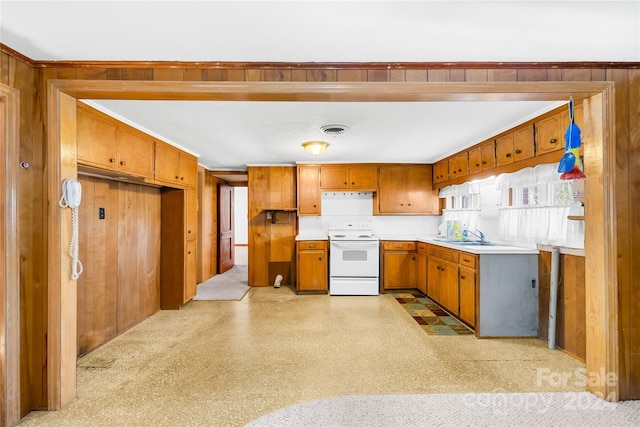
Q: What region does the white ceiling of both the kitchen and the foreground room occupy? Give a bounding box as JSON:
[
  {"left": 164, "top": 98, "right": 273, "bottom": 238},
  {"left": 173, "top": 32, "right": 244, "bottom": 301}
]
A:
[{"left": 0, "top": 0, "right": 640, "bottom": 169}]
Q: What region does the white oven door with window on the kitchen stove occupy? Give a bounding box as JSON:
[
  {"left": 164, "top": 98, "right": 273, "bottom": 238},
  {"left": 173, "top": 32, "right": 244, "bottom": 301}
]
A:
[{"left": 329, "top": 240, "right": 380, "bottom": 277}]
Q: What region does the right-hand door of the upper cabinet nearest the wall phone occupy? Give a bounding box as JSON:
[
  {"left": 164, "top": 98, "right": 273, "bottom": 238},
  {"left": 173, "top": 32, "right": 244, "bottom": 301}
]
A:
[{"left": 117, "top": 128, "right": 154, "bottom": 178}]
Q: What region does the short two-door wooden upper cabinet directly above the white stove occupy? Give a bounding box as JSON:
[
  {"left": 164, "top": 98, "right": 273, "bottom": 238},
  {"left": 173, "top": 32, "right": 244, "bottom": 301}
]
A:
[{"left": 320, "top": 165, "right": 378, "bottom": 191}]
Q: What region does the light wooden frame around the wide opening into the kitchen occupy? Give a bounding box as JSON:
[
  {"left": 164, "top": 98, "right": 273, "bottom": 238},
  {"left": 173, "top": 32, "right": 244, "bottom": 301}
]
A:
[{"left": 45, "top": 80, "right": 620, "bottom": 409}]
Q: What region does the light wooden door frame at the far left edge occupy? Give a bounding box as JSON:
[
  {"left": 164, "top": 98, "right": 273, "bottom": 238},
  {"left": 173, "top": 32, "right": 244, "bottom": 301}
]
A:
[{"left": 0, "top": 84, "right": 21, "bottom": 425}]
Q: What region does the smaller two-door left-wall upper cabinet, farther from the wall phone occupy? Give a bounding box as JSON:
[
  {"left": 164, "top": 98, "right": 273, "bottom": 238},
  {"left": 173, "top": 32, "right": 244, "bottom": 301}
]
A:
[{"left": 155, "top": 141, "right": 198, "bottom": 187}]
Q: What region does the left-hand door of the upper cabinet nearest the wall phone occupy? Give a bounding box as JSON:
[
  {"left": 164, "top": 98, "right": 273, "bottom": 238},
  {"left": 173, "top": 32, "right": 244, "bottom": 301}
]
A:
[{"left": 77, "top": 108, "right": 117, "bottom": 170}]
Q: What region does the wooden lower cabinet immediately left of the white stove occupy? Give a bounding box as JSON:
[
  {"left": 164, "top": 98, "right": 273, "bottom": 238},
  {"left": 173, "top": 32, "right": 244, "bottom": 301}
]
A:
[{"left": 296, "top": 240, "right": 329, "bottom": 292}]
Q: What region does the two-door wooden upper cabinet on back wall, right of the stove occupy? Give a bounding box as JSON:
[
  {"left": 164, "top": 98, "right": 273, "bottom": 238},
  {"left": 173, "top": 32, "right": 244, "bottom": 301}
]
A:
[{"left": 377, "top": 165, "right": 439, "bottom": 215}]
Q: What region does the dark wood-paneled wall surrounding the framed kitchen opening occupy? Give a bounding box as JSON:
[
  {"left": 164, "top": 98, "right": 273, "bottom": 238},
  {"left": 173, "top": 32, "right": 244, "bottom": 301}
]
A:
[{"left": 0, "top": 46, "right": 640, "bottom": 410}]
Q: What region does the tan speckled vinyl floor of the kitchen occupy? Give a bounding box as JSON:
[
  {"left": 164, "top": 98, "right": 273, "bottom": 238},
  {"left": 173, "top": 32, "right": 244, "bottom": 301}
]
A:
[{"left": 22, "top": 287, "right": 584, "bottom": 427}]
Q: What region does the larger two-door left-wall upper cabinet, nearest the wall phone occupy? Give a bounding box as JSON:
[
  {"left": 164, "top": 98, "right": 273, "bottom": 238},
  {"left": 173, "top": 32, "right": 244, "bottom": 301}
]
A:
[{"left": 77, "top": 103, "right": 154, "bottom": 178}]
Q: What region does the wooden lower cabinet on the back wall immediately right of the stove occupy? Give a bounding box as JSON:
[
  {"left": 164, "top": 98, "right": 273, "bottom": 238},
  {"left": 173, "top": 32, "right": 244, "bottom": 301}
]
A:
[{"left": 381, "top": 241, "right": 418, "bottom": 290}]
